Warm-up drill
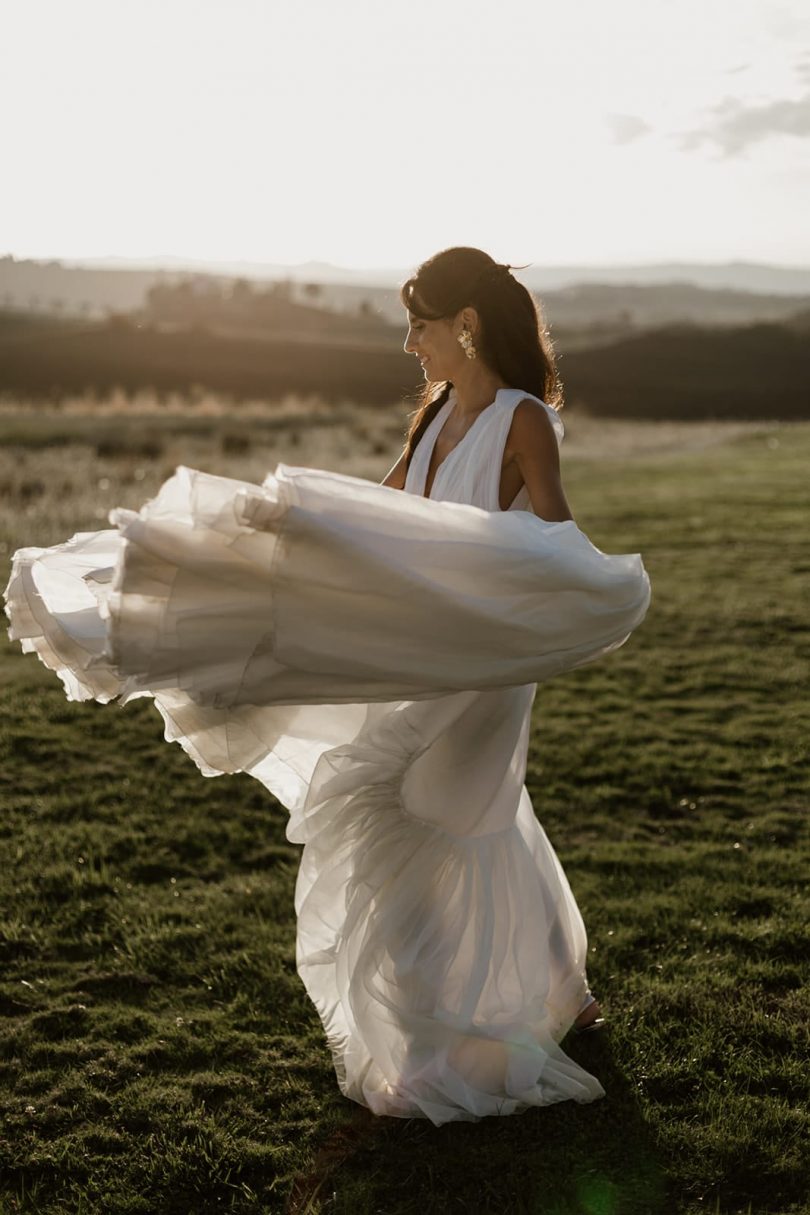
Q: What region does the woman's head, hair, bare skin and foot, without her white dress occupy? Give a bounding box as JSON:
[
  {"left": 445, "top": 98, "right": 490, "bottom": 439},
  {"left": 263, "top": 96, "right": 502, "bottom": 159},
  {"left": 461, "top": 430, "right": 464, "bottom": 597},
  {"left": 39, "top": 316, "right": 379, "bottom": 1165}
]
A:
[{"left": 383, "top": 247, "right": 605, "bottom": 1033}]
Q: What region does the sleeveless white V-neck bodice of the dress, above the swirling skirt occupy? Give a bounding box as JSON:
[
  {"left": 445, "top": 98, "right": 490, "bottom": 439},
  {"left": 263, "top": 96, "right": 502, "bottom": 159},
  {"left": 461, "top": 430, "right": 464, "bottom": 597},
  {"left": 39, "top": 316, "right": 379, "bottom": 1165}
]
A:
[{"left": 404, "top": 388, "right": 565, "bottom": 513}]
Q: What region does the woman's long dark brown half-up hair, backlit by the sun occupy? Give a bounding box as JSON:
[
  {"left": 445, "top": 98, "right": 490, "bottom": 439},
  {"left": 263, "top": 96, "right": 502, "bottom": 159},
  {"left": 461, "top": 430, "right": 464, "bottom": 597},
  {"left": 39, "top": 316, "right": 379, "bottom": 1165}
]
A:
[{"left": 400, "top": 245, "right": 563, "bottom": 467}]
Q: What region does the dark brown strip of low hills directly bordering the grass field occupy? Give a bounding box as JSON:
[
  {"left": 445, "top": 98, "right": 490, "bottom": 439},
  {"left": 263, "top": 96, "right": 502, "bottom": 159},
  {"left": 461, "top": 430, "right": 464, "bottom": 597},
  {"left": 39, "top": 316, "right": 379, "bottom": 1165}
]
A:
[{"left": 0, "top": 306, "right": 810, "bottom": 419}]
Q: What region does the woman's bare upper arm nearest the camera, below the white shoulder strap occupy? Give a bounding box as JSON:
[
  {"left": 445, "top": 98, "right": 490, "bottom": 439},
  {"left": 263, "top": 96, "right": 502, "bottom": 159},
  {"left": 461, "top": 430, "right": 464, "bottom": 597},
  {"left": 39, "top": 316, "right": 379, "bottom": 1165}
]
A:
[{"left": 504, "top": 397, "right": 573, "bottom": 522}]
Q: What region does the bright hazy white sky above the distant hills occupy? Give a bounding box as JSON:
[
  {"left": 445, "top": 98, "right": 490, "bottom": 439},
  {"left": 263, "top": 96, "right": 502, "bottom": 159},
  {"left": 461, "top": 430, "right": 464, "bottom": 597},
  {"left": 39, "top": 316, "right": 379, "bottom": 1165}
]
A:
[{"left": 0, "top": 0, "right": 810, "bottom": 266}]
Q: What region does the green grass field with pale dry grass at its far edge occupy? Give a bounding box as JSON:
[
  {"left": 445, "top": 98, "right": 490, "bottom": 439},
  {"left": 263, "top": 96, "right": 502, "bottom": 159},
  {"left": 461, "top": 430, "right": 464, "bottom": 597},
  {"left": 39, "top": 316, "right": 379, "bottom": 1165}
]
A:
[{"left": 0, "top": 402, "right": 810, "bottom": 1215}]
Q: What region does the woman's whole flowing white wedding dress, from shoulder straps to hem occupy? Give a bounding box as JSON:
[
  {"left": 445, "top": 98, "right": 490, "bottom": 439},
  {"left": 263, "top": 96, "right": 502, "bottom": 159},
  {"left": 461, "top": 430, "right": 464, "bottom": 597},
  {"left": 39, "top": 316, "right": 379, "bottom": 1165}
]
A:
[{"left": 6, "top": 389, "right": 651, "bottom": 1125}]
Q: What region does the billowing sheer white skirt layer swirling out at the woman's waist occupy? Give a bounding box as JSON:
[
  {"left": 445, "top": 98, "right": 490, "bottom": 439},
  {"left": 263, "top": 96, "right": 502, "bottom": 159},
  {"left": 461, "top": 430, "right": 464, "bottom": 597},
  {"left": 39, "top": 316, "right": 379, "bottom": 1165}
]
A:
[{"left": 6, "top": 464, "right": 648, "bottom": 707}]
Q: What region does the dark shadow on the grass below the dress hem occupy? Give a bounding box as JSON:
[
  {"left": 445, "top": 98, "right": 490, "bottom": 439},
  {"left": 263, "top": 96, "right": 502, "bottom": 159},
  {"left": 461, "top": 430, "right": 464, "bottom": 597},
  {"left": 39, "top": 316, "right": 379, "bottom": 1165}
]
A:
[{"left": 284, "top": 1029, "right": 678, "bottom": 1215}]
